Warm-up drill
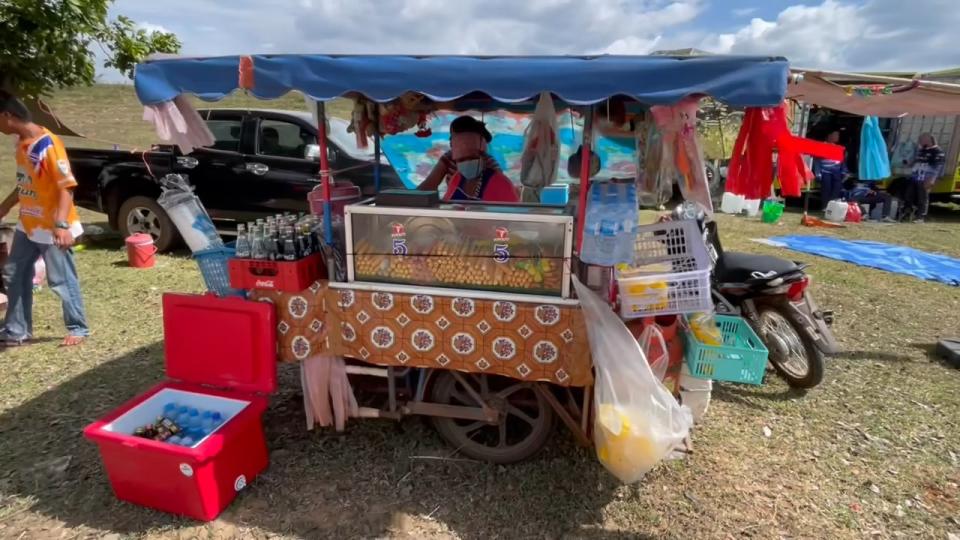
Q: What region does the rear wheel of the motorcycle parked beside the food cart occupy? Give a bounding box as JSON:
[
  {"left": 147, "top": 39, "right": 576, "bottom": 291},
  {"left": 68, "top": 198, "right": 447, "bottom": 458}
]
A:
[{"left": 757, "top": 303, "right": 824, "bottom": 388}]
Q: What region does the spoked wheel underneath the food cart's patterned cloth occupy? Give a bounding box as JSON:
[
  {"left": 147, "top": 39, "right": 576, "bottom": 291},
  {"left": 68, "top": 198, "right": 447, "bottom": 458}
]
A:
[{"left": 430, "top": 371, "right": 555, "bottom": 464}]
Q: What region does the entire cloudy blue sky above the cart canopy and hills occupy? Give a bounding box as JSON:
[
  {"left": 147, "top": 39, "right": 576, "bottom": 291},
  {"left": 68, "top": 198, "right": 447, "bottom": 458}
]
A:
[{"left": 103, "top": 0, "right": 960, "bottom": 80}]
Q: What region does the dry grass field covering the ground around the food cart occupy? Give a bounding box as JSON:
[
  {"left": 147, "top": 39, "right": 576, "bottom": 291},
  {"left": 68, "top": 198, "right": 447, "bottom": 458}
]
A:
[{"left": 0, "top": 87, "right": 960, "bottom": 540}]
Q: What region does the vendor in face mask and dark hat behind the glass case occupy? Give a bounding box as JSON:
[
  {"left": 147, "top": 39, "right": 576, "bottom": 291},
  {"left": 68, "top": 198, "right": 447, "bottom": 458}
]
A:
[{"left": 417, "top": 116, "right": 520, "bottom": 203}]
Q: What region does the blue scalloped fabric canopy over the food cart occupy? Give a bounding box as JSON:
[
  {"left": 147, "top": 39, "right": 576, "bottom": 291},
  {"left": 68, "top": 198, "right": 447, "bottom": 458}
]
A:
[{"left": 134, "top": 54, "right": 789, "bottom": 107}]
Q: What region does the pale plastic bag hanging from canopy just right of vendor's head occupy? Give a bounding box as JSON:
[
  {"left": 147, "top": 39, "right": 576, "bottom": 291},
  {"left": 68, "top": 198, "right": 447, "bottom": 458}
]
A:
[{"left": 520, "top": 92, "right": 560, "bottom": 202}]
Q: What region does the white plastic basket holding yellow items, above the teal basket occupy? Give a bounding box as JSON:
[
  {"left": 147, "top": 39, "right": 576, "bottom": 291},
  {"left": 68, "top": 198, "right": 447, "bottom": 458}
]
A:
[{"left": 617, "top": 220, "right": 713, "bottom": 319}]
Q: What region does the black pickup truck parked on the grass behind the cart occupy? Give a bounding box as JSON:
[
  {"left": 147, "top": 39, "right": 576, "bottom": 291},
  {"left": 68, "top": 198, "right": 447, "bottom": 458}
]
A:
[{"left": 68, "top": 109, "right": 403, "bottom": 251}]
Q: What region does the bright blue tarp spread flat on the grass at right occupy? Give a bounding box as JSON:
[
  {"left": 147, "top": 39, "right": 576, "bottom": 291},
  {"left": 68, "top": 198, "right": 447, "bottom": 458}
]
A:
[{"left": 770, "top": 236, "right": 960, "bottom": 286}]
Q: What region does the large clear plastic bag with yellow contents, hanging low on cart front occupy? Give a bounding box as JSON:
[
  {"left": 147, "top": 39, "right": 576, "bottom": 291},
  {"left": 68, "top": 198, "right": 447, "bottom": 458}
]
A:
[{"left": 573, "top": 278, "right": 693, "bottom": 483}]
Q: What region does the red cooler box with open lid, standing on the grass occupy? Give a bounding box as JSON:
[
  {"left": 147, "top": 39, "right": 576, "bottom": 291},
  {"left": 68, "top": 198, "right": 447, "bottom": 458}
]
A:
[{"left": 84, "top": 294, "right": 277, "bottom": 521}]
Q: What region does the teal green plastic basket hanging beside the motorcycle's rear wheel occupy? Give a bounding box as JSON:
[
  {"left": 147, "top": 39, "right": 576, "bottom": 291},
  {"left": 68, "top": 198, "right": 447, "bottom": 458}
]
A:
[{"left": 684, "top": 315, "right": 769, "bottom": 384}]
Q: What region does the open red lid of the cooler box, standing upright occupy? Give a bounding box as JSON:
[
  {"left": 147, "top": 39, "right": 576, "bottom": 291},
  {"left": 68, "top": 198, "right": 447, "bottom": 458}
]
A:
[{"left": 163, "top": 293, "right": 277, "bottom": 393}]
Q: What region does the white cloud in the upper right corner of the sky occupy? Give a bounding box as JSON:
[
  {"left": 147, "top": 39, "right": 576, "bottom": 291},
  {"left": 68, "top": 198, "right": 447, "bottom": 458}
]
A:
[{"left": 700, "top": 0, "right": 960, "bottom": 71}]
